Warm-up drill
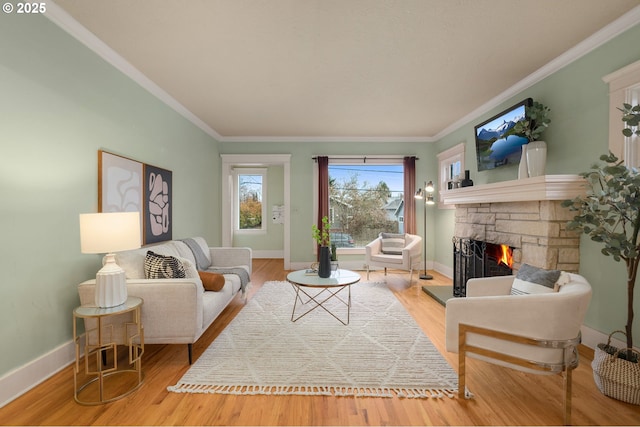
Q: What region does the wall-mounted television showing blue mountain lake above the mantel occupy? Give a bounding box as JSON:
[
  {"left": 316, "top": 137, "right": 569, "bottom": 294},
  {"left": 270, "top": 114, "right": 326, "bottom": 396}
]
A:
[{"left": 474, "top": 98, "right": 533, "bottom": 171}]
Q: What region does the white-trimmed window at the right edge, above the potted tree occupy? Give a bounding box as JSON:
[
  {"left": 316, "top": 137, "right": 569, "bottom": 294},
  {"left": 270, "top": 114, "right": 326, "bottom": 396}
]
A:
[{"left": 602, "top": 61, "right": 640, "bottom": 168}]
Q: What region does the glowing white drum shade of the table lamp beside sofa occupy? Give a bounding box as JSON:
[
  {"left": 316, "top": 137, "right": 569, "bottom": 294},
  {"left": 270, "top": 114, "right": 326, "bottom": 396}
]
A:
[{"left": 80, "top": 212, "right": 140, "bottom": 254}]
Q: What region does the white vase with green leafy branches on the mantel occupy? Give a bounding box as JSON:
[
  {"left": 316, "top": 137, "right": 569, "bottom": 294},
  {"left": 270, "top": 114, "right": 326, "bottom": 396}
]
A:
[{"left": 513, "top": 101, "right": 551, "bottom": 178}]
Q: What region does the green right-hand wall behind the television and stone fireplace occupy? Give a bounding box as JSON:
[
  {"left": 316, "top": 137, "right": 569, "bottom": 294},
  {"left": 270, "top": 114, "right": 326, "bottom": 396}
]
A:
[{"left": 435, "top": 25, "right": 640, "bottom": 343}]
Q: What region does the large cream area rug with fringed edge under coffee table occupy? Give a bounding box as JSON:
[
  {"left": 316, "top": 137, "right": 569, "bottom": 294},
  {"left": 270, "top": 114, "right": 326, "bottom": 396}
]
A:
[{"left": 168, "top": 282, "right": 458, "bottom": 398}]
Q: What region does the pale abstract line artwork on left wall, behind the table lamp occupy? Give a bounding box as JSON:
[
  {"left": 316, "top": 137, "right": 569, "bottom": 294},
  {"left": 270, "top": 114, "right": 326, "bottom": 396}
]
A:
[{"left": 98, "top": 150, "right": 143, "bottom": 217}]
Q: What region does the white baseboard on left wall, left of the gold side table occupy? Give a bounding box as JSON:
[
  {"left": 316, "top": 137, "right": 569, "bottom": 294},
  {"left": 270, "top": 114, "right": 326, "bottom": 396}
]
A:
[{"left": 0, "top": 341, "right": 76, "bottom": 408}]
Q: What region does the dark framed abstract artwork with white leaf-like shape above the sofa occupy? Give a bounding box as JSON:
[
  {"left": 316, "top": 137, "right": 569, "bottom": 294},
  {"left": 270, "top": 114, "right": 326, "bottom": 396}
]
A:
[{"left": 142, "top": 164, "right": 173, "bottom": 244}]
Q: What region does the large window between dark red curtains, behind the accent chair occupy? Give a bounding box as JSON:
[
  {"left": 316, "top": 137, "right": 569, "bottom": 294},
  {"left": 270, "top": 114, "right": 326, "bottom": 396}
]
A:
[{"left": 329, "top": 157, "right": 404, "bottom": 248}]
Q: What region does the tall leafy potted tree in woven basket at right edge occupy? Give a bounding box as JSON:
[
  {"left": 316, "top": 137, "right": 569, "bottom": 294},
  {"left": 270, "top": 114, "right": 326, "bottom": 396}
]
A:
[{"left": 562, "top": 145, "right": 640, "bottom": 405}]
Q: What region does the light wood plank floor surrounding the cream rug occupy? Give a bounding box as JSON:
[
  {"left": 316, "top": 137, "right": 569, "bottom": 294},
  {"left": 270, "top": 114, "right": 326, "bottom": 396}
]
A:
[{"left": 0, "top": 260, "right": 640, "bottom": 425}]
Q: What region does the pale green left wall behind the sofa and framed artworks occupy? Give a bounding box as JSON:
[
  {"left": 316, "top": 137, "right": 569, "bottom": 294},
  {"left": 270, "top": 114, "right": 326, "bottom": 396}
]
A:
[{"left": 0, "top": 14, "right": 220, "bottom": 376}]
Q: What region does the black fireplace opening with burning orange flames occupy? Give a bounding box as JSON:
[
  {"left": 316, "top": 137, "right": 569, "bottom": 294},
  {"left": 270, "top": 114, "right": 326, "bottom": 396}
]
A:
[{"left": 453, "top": 238, "right": 513, "bottom": 297}]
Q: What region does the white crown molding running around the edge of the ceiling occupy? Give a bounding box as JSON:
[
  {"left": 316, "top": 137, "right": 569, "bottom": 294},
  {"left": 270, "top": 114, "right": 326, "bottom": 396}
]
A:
[{"left": 45, "top": 0, "right": 640, "bottom": 143}]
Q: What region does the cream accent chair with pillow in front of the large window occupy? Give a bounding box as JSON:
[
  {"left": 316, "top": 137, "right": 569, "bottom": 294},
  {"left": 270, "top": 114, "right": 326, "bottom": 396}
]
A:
[{"left": 365, "top": 234, "right": 422, "bottom": 283}]
